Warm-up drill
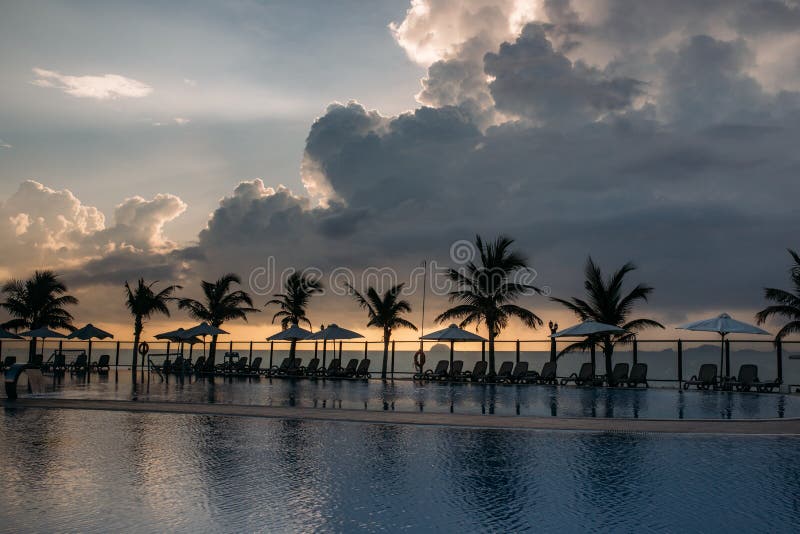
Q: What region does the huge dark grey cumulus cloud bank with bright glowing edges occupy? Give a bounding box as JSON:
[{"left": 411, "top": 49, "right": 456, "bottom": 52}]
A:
[{"left": 2, "top": 0, "right": 800, "bottom": 332}]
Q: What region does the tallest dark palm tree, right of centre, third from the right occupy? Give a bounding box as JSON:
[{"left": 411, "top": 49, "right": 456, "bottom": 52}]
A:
[{"left": 436, "top": 235, "right": 542, "bottom": 374}]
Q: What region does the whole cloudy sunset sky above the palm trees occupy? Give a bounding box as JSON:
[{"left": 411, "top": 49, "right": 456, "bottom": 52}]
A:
[{"left": 0, "top": 0, "right": 800, "bottom": 339}]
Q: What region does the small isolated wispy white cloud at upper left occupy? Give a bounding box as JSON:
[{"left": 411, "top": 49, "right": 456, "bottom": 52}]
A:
[{"left": 31, "top": 67, "right": 153, "bottom": 100}]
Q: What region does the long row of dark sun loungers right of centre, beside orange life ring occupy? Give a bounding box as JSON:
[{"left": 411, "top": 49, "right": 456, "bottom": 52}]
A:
[{"left": 414, "top": 360, "right": 648, "bottom": 387}]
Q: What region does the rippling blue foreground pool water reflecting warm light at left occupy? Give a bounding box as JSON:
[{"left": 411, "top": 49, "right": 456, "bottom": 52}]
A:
[{"left": 0, "top": 406, "right": 800, "bottom": 532}]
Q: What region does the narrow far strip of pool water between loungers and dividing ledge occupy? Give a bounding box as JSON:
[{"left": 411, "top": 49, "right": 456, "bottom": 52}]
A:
[{"left": 17, "top": 371, "right": 800, "bottom": 419}]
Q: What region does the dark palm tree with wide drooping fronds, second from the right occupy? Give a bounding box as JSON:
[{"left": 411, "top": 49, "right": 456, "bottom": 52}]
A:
[{"left": 551, "top": 256, "right": 664, "bottom": 376}]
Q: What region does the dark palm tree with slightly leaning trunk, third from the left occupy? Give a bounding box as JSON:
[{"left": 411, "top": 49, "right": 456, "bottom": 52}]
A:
[{"left": 178, "top": 273, "right": 260, "bottom": 369}]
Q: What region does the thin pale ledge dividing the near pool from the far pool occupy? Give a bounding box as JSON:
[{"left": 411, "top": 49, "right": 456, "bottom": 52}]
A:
[{"left": 4, "top": 397, "right": 800, "bottom": 436}]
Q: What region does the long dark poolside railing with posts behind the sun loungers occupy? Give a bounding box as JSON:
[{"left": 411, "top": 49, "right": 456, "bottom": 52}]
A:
[{"left": 0, "top": 338, "right": 800, "bottom": 386}]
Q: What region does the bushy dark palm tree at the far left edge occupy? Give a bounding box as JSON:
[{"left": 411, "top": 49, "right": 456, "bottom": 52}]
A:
[{"left": 0, "top": 271, "right": 78, "bottom": 362}]
